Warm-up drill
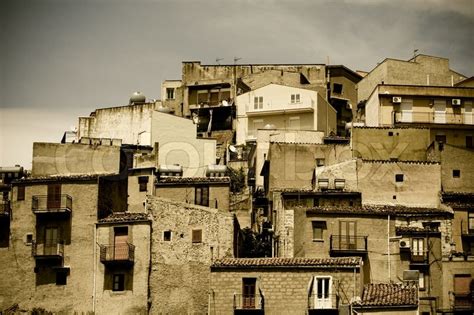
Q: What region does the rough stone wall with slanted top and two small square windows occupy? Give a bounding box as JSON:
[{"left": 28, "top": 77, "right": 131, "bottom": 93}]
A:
[{"left": 148, "top": 197, "right": 233, "bottom": 314}]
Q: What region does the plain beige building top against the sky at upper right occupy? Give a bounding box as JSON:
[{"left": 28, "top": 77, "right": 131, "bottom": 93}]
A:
[{"left": 357, "top": 55, "right": 466, "bottom": 102}]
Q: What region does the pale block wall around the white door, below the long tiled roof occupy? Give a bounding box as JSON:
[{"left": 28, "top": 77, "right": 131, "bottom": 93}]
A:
[{"left": 210, "top": 267, "right": 362, "bottom": 315}]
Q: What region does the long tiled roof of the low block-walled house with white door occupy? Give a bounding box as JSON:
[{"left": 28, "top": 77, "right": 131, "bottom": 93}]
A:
[{"left": 211, "top": 257, "right": 362, "bottom": 268}]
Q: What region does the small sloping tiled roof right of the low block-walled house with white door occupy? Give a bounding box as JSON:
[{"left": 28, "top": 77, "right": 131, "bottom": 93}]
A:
[{"left": 355, "top": 283, "right": 418, "bottom": 307}]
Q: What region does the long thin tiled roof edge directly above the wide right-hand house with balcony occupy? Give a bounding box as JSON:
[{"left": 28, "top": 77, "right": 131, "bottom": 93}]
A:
[{"left": 306, "top": 205, "right": 453, "bottom": 216}]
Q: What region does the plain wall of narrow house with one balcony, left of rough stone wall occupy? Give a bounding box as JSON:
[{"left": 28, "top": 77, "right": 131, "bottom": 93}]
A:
[{"left": 95, "top": 222, "right": 151, "bottom": 315}]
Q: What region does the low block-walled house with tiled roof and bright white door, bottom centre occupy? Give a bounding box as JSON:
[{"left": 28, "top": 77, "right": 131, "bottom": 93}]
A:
[{"left": 208, "top": 257, "right": 363, "bottom": 314}]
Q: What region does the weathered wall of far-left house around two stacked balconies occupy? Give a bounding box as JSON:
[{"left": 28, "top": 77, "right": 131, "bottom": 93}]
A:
[{"left": 0, "top": 182, "right": 98, "bottom": 313}]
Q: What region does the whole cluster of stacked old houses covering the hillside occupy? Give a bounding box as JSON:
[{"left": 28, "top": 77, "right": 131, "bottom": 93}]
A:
[{"left": 0, "top": 54, "right": 474, "bottom": 315}]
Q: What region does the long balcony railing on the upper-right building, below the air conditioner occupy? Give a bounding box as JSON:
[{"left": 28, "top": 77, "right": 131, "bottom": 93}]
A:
[{"left": 394, "top": 111, "right": 474, "bottom": 125}]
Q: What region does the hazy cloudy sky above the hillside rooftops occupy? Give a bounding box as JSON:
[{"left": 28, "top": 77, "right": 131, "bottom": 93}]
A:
[{"left": 0, "top": 0, "right": 474, "bottom": 168}]
